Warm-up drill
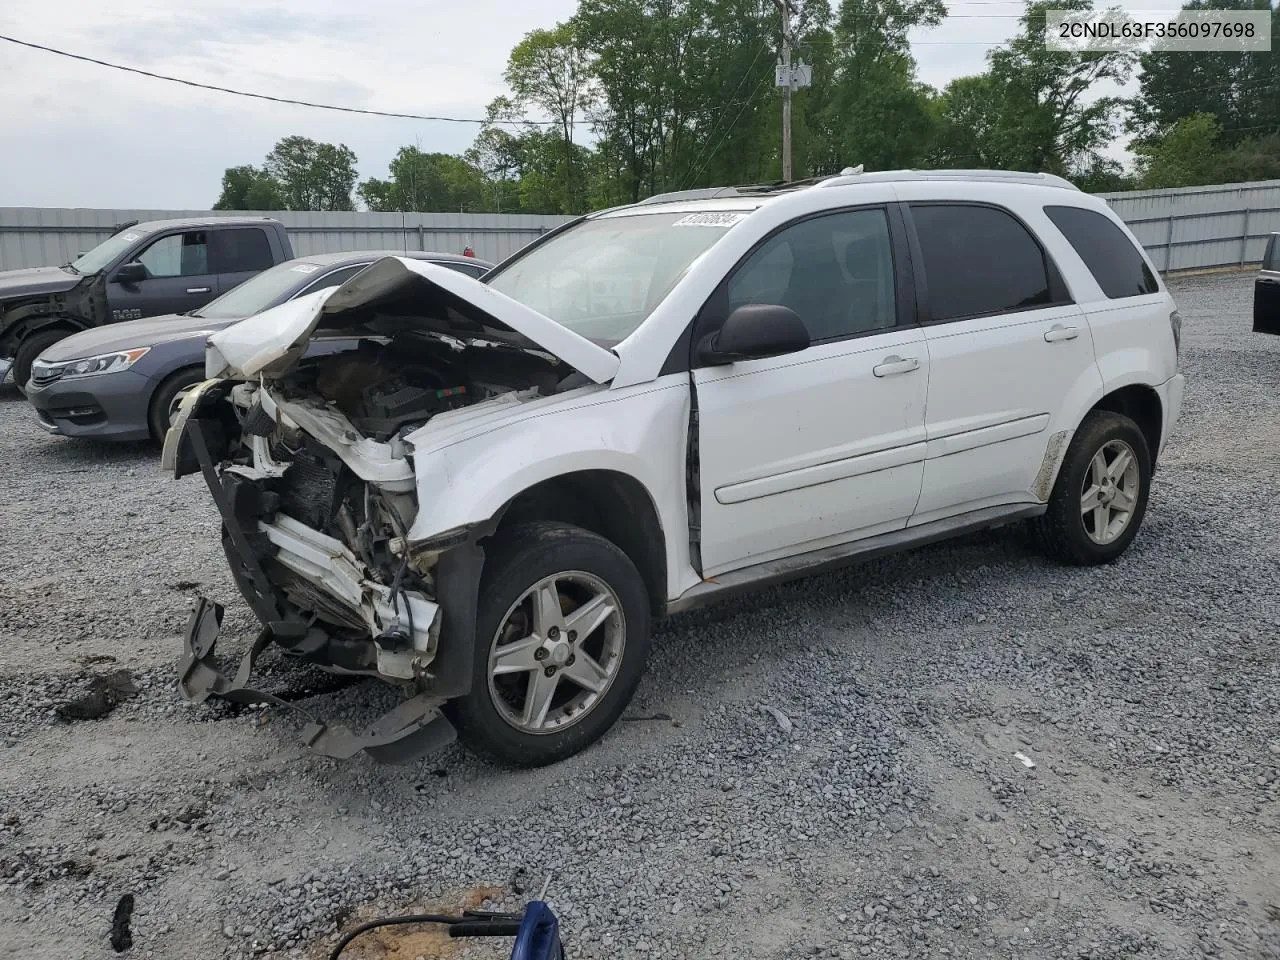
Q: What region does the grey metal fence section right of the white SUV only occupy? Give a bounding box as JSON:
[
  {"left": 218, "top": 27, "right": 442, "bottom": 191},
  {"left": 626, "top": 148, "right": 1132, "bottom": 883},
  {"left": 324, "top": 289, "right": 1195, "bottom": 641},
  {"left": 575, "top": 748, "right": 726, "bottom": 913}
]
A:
[{"left": 1102, "top": 180, "right": 1280, "bottom": 273}]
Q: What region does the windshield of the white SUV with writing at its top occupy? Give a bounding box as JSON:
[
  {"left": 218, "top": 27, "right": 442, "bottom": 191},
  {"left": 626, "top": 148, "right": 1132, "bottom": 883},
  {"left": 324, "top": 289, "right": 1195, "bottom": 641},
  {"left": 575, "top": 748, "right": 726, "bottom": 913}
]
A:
[{"left": 485, "top": 210, "right": 746, "bottom": 347}]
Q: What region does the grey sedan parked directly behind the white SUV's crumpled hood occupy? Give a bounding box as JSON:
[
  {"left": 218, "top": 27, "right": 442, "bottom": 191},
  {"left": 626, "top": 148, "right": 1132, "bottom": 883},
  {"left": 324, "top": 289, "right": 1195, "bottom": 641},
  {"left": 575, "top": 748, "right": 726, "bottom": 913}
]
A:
[{"left": 27, "top": 251, "right": 493, "bottom": 440}]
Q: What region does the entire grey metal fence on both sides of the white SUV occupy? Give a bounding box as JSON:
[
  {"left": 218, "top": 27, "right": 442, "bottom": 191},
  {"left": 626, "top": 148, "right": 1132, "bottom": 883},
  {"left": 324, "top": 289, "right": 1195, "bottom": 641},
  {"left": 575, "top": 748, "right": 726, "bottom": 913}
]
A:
[{"left": 0, "top": 180, "right": 1280, "bottom": 273}]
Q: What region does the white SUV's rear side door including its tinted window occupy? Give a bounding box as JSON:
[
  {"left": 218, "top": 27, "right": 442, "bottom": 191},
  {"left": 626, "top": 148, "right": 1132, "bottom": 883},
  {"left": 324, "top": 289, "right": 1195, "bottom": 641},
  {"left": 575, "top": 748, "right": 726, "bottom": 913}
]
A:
[{"left": 909, "top": 201, "right": 1100, "bottom": 525}]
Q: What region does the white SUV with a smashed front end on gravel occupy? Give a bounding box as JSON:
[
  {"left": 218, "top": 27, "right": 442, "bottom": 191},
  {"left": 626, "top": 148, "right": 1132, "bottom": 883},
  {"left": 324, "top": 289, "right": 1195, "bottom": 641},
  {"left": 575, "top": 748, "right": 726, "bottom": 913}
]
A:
[{"left": 164, "top": 172, "right": 1183, "bottom": 764}]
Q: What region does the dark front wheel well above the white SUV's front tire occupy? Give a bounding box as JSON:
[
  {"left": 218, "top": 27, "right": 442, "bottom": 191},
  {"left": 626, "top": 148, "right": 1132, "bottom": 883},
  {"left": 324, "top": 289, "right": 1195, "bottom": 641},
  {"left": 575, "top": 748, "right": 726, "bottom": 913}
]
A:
[{"left": 494, "top": 468, "right": 667, "bottom": 616}]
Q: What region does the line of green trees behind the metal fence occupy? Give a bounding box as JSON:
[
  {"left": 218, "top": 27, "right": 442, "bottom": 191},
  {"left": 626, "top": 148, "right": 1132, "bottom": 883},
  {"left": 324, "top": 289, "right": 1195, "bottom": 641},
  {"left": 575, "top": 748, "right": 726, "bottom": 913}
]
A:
[{"left": 209, "top": 0, "right": 1280, "bottom": 214}]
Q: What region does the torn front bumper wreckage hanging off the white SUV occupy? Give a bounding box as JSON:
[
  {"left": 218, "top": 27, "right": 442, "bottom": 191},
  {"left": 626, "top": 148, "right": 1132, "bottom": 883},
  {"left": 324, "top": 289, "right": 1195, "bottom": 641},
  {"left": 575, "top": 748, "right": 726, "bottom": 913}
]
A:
[{"left": 175, "top": 417, "right": 454, "bottom": 760}]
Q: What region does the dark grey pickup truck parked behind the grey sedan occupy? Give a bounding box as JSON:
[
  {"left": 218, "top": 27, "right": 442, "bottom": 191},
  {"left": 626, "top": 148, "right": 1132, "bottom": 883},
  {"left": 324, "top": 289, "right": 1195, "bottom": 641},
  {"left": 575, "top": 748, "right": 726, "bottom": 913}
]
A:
[{"left": 0, "top": 216, "right": 293, "bottom": 389}]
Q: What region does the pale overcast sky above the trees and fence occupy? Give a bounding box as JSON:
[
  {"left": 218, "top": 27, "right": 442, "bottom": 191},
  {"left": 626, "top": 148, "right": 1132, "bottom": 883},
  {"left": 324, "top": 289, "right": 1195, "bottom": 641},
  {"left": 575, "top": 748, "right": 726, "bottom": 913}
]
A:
[{"left": 0, "top": 0, "right": 1141, "bottom": 209}]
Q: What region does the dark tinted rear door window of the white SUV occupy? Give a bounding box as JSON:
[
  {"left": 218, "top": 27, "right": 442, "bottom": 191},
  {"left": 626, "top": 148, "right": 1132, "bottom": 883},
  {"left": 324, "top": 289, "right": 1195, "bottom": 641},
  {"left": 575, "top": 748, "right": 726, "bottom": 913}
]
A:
[{"left": 910, "top": 204, "right": 1065, "bottom": 320}]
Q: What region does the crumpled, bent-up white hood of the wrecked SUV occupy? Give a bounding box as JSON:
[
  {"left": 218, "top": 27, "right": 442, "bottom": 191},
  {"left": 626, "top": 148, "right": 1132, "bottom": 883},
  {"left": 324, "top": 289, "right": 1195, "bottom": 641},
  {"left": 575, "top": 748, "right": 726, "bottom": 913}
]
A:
[{"left": 205, "top": 257, "right": 618, "bottom": 383}]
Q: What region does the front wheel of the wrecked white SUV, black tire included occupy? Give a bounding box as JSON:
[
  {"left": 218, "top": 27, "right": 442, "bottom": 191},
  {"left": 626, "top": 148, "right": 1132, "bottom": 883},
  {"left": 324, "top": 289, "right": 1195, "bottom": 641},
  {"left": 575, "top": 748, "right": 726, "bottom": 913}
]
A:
[{"left": 444, "top": 522, "right": 650, "bottom": 767}]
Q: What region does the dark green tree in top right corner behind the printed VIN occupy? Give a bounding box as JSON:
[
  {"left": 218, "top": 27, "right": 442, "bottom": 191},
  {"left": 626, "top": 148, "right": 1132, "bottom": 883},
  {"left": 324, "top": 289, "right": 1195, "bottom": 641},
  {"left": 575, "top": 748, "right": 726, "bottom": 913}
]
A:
[{"left": 1129, "top": 0, "right": 1280, "bottom": 146}]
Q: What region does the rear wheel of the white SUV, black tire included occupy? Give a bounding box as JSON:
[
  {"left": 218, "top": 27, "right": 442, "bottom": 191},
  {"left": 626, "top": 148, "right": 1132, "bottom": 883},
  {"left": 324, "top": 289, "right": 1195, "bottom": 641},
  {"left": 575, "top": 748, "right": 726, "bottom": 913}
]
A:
[{"left": 1033, "top": 410, "right": 1151, "bottom": 566}]
